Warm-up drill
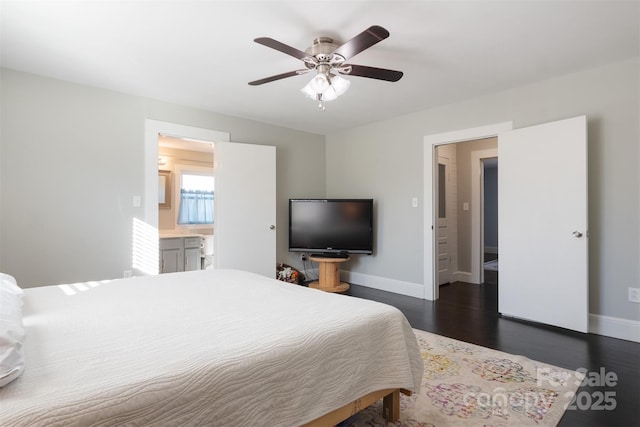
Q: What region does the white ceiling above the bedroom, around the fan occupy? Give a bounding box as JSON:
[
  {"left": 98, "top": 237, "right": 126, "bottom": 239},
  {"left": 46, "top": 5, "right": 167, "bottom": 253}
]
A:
[{"left": 0, "top": 0, "right": 640, "bottom": 134}]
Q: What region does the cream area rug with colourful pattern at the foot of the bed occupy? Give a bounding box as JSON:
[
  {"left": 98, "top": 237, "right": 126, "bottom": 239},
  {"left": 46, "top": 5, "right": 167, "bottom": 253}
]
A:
[{"left": 340, "top": 329, "right": 584, "bottom": 427}]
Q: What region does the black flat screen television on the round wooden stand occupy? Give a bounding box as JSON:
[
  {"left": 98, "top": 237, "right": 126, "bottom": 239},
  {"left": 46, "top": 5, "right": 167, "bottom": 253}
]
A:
[{"left": 289, "top": 199, "right": 373, "bottom": 256}]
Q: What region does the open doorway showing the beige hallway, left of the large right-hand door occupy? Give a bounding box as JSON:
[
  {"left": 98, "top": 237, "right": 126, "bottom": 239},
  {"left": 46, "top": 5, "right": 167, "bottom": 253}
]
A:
[{"left": 434, "top": 137, "right": 498, "bottom": 285}]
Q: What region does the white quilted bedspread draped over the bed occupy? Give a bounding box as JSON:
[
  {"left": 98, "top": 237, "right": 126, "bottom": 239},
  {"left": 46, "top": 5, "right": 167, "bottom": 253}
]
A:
[{"left": 0, "top": 270, "right": 422, "bottom": 426}]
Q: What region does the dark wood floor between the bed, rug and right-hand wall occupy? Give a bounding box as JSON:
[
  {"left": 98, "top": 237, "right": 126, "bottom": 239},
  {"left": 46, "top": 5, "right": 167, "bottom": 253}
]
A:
[{"left": 349, "top": 282, "right": 640, "bottom": 426}]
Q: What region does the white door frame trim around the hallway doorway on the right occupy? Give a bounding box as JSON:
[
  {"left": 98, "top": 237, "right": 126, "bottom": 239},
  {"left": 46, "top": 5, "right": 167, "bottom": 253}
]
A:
[{"left": 423, "top": 121, "right": 513, "bottom": 300}]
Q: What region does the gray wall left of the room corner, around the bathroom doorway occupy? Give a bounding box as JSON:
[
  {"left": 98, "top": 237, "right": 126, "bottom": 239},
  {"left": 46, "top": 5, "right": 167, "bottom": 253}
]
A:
[{"left": 0, "top": 69, "right": 325, "bottom": 287}]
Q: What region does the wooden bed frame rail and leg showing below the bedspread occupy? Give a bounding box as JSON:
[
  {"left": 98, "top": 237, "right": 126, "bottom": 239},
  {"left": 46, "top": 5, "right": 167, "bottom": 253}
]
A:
[{"left": 303, "top": 388, "right": 411, "bottom": 427}]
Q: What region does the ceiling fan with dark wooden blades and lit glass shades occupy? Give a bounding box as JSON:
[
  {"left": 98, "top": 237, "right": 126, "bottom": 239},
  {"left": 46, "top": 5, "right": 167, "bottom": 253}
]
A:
[{"left": 249, "top": 25, "right": 402, "bottom": 110}]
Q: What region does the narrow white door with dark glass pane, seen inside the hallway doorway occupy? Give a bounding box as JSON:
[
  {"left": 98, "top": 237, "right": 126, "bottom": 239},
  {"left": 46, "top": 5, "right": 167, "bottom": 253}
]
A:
[{"left": 437, "top": 156, "right": 451, "bottom": 285}]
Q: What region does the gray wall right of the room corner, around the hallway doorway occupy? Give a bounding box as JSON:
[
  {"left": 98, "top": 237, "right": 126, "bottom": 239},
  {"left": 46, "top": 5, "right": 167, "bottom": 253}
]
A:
[{"left": 326, "top": 58, "right": 640, "bottom": 320}]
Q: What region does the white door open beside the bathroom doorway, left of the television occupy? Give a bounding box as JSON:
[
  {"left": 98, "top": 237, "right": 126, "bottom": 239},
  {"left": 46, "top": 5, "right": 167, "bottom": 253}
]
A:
[{"left": 213, "top": 142, "right": 276, "bottom": 277}]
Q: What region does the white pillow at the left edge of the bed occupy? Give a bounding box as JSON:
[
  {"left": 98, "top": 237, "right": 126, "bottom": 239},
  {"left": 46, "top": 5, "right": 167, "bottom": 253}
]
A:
[{"left": 0, "top": 273, "right": 25, "bottom": 387}]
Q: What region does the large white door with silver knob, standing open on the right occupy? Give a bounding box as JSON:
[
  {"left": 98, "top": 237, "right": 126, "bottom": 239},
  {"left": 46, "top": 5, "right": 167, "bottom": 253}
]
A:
[{"left": 498, "top": 116, "right": 589, "bottom": 332}]
